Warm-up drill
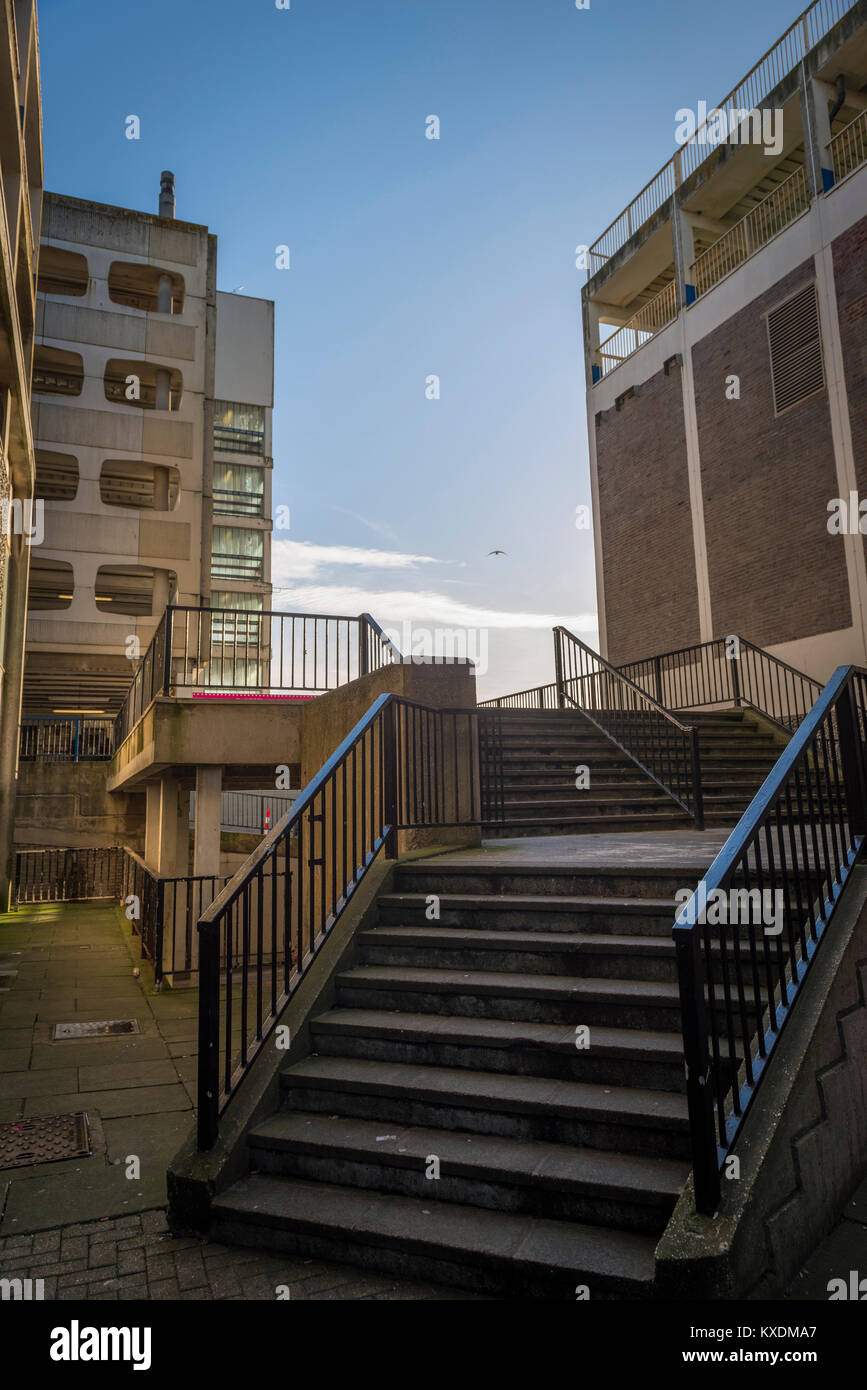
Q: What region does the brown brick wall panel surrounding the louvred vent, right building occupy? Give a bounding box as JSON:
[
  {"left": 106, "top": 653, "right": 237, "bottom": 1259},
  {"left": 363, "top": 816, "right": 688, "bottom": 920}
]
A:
[{"left": 692, "top": 260, "right": 850, "bottom": 646}]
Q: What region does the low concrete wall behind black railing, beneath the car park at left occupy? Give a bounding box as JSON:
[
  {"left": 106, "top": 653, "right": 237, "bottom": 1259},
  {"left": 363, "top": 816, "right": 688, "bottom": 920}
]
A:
[{"left": 15, "top": 762, "right": 145, "bottom": 852}]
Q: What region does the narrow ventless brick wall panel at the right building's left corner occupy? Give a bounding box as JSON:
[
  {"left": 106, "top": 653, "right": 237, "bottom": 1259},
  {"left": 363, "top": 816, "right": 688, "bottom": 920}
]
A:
[{"left": 596, "top": 367, "right": 699, "bottom": 664}]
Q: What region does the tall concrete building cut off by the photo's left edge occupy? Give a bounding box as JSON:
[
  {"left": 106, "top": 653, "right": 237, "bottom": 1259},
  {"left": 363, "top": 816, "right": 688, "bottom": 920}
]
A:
[{"left": 0, "top": 0, "right": 43, "bottom": 906}]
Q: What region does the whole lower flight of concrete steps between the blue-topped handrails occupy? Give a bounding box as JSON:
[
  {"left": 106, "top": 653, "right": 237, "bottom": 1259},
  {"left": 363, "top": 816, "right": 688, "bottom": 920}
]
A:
[{"left": 211, "top": 850, "right": 706, "bottom": 1300}]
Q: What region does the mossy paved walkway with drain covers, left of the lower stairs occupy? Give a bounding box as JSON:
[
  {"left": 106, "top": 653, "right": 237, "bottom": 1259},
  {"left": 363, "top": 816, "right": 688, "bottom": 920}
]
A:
[{"left": 0, "top": 902, "right": 472, "bottom": 1301}]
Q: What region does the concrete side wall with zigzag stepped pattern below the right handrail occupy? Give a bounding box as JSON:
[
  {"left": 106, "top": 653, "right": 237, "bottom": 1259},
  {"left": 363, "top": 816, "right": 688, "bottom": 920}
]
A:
[{"left": 656, "top": 867, "right": 867, "bottom": 1298}]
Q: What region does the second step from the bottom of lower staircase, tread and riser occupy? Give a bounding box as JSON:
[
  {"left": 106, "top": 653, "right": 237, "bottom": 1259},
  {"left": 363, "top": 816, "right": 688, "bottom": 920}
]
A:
[{"left": 249, "top": 1112, "right": 689, "bottom": 1233}]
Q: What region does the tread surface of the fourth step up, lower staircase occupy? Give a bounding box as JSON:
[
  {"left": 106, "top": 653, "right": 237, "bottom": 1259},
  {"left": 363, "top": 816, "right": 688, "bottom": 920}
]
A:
[{"left": 313, "top": 1008, "right": 684, "bottom": 1062}]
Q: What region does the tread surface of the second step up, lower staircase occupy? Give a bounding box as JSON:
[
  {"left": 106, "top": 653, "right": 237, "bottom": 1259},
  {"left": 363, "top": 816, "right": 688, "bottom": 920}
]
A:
[{"left": 249, "top": 1111, "right": 689, "bottom": 1200}]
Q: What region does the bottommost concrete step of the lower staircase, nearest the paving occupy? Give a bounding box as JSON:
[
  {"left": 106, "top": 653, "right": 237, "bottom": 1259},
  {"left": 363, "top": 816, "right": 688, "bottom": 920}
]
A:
[{"left": 211, "top": 1173, "right": 656, "bottom": 1301}]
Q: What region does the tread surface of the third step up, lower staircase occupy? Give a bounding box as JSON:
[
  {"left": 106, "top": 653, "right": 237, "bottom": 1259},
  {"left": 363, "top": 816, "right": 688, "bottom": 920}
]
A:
[{"left": 281, "top": 1056, "right": 688, "bottom": 1131}]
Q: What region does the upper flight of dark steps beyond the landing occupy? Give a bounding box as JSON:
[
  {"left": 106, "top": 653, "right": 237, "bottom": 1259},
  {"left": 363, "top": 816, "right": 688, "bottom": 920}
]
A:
[{"left": 485, "top": 709, "right": 785, "bottom": 837}]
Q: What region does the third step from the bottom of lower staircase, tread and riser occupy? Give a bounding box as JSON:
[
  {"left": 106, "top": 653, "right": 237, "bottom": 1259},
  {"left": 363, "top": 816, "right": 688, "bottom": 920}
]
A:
[{"left": 281, "top": 1056, "right": 691, "bottom": 1159}]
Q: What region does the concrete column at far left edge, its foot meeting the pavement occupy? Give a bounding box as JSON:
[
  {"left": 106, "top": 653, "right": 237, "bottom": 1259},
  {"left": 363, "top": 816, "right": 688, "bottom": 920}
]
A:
[{"left": 0, "top": 532, "right": 31, "bottom": 912}]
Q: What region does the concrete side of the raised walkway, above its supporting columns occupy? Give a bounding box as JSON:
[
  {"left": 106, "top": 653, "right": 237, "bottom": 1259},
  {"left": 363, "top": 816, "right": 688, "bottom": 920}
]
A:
[{"left": 108, "top": 695, "right": 304, "bottom": 792}]
